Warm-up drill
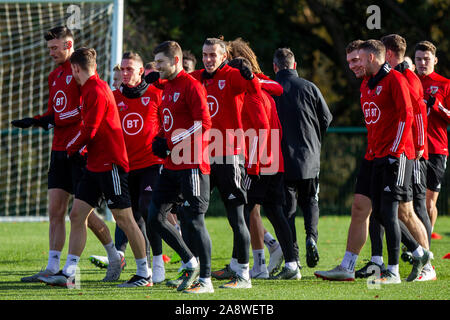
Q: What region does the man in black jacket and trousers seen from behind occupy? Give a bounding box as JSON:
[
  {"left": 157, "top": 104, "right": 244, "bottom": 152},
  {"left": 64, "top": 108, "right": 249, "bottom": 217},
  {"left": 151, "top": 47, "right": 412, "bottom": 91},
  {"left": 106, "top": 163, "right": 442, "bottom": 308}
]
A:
[{"left": 273, "top": 48, "right": 333, "bottom": 268}]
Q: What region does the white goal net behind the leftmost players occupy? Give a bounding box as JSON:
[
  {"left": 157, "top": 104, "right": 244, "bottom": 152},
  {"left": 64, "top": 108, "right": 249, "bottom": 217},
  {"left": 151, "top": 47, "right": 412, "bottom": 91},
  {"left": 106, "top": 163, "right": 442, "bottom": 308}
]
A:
[{"left": 0, "top": 0, "right": 123, "bottom": 221}]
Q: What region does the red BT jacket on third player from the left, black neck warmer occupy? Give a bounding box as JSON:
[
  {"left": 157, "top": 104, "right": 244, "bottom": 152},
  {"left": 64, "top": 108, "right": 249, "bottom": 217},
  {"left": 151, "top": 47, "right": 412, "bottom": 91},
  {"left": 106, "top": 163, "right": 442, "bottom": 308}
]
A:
[{"left": 113, "top": 85, "right": 164, "bottom": 170}]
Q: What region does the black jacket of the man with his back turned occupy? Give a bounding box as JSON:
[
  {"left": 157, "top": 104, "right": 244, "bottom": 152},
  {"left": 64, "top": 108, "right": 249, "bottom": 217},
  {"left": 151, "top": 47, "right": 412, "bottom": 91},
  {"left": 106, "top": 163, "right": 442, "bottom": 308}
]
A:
[{"left": 274, "top": 69, "right": 333, "bottom": 181}]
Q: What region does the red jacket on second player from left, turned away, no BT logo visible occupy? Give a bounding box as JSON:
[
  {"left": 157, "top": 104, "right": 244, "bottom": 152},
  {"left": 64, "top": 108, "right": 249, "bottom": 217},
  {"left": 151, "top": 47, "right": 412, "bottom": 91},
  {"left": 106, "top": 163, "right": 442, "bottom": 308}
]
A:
[{"left": 67, "top": 74, "right": 129, "bottom": 172}]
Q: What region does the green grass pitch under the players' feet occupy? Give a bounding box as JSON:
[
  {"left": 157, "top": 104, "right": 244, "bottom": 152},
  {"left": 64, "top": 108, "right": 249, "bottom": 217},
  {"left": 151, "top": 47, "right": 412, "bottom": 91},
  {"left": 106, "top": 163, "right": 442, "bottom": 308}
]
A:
[{"left": 0, "top": 216, "right": 450, "bottom": 301}]
